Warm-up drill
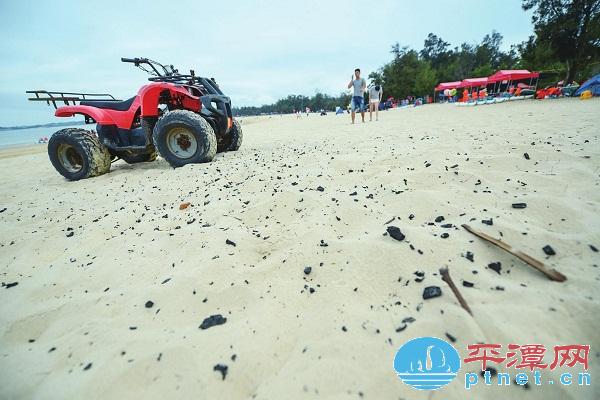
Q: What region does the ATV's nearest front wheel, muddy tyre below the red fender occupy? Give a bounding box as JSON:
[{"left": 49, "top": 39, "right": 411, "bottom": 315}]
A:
[{"left": 153, "top": 110, "right": 217, "bottom": 168}]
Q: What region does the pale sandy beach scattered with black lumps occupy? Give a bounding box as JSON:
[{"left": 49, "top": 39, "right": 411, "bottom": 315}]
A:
[{"left": 0, "top": 99, "right": 600, "bottom": 399}]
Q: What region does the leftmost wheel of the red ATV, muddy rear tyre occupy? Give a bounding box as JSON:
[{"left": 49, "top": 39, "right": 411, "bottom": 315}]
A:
[{"left": 48, "top": 128, "right": 110, "bottom": 181}]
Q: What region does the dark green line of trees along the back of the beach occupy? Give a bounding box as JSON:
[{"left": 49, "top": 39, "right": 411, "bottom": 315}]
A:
[{"left": 234, "top": 0, "right": 600, "bottom": 115}]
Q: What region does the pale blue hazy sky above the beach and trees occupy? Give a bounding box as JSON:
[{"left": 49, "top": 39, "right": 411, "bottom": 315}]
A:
[{"left": 0, "top": 0, "right": 533, "bottom": 126}]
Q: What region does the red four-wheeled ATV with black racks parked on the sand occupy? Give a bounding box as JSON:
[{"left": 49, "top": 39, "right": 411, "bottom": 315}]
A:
[{"left": 27, "top": 58, "right": 242, "bottom": 181}]
